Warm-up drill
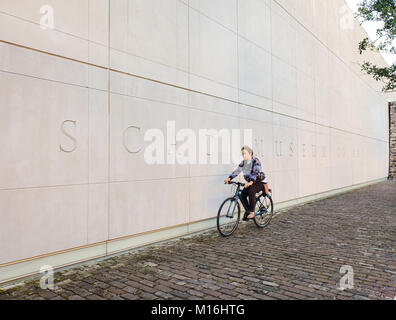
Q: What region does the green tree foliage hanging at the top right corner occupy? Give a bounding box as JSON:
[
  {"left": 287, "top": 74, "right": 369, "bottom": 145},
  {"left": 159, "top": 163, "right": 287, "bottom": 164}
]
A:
[{"left": 357, "top": 0, "right": 396, "bottom": 91}]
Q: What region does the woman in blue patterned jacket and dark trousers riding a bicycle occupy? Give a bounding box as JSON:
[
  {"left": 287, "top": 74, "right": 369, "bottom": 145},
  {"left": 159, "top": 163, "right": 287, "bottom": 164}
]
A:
[{"left": 224, "top": 146, "right": 268, "bottom": 220}]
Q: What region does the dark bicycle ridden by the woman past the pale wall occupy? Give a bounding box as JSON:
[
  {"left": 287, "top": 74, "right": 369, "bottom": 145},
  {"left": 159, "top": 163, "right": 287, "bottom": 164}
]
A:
[{"left": 217, "top": 181, "right": 274, "bottom": 237}]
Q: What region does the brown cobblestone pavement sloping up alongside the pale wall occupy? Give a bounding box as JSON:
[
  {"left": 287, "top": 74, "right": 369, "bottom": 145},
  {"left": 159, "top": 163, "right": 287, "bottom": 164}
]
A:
[{"left": 0, "top": 181, "right": 396, "bottom": 300}]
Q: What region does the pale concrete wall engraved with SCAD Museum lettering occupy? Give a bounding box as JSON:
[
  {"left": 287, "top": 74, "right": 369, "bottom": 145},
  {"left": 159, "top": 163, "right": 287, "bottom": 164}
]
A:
[{"left": 0, "top": 0, "right": 389, "bottom": 280}]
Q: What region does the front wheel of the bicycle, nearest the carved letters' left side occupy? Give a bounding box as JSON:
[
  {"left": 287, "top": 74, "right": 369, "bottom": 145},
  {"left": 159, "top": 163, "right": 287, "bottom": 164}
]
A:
[{"left": 217, "top": 198, "right": 241, "bottom": 237}]
